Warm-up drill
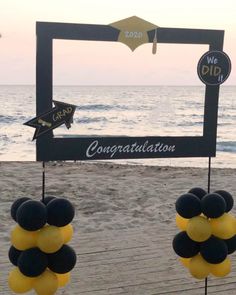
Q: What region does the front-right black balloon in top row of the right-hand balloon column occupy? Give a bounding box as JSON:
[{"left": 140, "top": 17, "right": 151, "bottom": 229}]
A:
[{"left": 201, "top": 193, "right": 226, "bottom": 218}]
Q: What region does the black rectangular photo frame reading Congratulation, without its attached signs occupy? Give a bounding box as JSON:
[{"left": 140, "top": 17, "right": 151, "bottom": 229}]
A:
[{"left": 36, "top": 22, "right": 224, "bottom": 161}]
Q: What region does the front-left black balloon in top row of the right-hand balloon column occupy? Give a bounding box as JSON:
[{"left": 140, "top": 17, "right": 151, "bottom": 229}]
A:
[{"left": 175, "top": 193, "right": 202, "bottom": 218}]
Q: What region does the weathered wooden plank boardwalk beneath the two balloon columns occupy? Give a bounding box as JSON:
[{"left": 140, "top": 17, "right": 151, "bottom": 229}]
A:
[{"left": 0, "top": 225, "right": 236, "bottom": 295}]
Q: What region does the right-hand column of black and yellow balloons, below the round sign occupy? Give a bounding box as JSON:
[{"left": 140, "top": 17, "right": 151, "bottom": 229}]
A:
[{"left": 172, "top": 187, "right": 236, "bottom": 279}]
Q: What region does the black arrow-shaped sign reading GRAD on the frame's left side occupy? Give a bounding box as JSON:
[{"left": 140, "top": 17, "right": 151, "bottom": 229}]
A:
[{"left": 24, "top": 100, "right": 76, "bottom": 140}]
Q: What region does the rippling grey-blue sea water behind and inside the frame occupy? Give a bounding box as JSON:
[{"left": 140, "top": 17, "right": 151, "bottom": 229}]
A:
[{"left": 0, "top": 85, "right": 236, "bottom": 168}]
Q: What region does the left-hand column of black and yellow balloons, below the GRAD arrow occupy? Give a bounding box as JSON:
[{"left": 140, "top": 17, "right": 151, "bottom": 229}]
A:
[{"left": 8, "top": 196, "right": 76, "bottom": 295}]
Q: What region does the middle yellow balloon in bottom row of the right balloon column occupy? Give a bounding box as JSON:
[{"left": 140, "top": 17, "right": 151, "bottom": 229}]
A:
[{"left": 189, "top": 254, "right": 210, "bottom": 280}]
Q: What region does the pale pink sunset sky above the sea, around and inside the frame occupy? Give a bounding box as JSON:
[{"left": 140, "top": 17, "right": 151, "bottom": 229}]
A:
[{"left": 0, "top": 0, "right": 236, "bottom": 85}]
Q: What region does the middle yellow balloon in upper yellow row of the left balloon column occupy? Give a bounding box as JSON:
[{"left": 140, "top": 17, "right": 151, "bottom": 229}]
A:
[{"left": 37, "top": 225, "right": 64, "bottom": 253}]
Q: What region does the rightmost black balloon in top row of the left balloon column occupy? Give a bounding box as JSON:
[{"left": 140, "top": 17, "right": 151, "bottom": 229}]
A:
[{"left": 47, "top": 198, "right": 75, "bottom": 227}]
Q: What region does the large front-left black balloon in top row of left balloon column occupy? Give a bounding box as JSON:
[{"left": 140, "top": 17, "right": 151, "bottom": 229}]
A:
[{"left": 16, "top": 200, "right": 47, "bottom": 231}]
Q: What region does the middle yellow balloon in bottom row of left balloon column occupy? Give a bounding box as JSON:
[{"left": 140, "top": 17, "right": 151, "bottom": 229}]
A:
[{"left": 33, "top": 269, "right": 58, "bottom": 295}]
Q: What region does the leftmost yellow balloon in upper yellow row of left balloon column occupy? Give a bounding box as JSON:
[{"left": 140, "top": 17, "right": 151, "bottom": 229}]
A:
[{"left": 11, "top": 225, "right": 38, "bottom": 250}]
